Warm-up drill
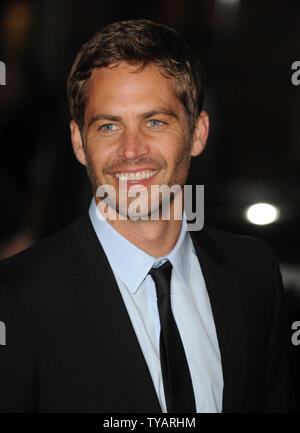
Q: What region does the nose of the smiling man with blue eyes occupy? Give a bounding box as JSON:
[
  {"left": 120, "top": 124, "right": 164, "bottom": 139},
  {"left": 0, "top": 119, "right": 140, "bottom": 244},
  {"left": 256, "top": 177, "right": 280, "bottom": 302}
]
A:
[{"left": 118, "top": 130, "right": 149, "bottom": 159}]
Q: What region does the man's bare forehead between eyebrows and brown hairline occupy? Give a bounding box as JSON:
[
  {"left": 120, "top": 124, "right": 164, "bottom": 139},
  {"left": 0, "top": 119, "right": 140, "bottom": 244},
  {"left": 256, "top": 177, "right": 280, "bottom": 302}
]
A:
[{"left": 86, "top": 62, "right": 182, "bottom": 115}]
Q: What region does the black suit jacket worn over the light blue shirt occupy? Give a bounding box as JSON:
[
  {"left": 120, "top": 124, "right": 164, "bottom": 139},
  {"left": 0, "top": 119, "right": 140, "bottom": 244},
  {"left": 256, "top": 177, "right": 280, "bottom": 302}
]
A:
[{"left": 0, "top": 214, "right": 288, "bottom": 413}]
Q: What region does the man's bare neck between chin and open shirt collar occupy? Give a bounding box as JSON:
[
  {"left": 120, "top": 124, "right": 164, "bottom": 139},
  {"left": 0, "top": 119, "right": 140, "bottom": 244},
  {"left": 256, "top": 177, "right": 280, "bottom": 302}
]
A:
[{"left": 96, "top": 192, "right": 182, "bottom": 257}]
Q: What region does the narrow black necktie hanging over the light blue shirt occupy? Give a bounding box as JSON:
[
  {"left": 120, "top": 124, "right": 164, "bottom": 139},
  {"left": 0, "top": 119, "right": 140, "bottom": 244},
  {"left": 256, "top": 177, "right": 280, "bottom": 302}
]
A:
[{"left": 149, "top": 260, "right": 196, "bottom": 413}]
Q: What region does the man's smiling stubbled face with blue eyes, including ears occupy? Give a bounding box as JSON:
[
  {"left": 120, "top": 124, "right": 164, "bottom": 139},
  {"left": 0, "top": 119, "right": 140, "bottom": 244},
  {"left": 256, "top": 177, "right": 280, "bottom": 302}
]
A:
[{"left": 71, "top": 62, "right": 206, "bottom": 219}]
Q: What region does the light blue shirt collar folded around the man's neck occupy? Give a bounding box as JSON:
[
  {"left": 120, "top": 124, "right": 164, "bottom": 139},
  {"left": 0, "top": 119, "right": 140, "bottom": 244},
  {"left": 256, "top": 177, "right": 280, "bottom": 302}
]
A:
[{"left": 89, "top": 198, "right": 191, "bottom": 294}]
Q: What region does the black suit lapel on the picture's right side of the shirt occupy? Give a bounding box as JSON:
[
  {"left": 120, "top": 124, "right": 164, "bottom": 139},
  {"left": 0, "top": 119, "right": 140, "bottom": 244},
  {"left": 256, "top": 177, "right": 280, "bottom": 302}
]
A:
[{"left": 191, "top": 228, "right": 246, "bottom": 412}]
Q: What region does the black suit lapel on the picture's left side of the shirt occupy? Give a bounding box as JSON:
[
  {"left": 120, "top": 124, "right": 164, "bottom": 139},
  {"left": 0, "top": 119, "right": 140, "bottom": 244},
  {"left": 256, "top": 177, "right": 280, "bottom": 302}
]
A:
[{"left": 65, "top": 215, "right": 161, "bottom": 412}]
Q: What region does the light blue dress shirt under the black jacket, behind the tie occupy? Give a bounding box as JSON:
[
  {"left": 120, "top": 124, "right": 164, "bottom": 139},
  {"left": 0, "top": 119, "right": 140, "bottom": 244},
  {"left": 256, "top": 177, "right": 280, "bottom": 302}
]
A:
[{"left": 89, "top": 199, "right": 223, "bottom": 413}]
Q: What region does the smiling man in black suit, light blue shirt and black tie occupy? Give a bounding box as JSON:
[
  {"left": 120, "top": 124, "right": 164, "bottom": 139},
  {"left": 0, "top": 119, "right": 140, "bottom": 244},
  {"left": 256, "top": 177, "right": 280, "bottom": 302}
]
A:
[{"left": 0, "top": 20, "right": 287, "bottom": 413}]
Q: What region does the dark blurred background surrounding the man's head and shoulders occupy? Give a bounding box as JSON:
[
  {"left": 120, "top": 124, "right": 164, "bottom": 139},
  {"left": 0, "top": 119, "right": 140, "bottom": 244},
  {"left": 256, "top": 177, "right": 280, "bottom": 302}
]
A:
[{"left": 0, "top": 0, "right": 300, "bottom": 412}]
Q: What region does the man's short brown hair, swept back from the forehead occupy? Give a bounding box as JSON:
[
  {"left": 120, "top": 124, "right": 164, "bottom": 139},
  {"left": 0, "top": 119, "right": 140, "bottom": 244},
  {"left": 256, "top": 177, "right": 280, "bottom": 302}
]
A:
[{"left": 68, "top": 19, "right": 204, "bottom": 130}]
